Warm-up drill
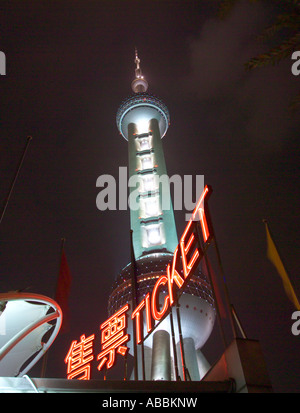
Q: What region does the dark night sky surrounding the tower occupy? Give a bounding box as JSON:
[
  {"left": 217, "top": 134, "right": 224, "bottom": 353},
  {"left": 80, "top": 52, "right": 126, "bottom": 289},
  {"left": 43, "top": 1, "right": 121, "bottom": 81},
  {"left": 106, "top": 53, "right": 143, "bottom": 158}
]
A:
[{"left": 0, "top": 0, "right": 300, "bottom": 392}]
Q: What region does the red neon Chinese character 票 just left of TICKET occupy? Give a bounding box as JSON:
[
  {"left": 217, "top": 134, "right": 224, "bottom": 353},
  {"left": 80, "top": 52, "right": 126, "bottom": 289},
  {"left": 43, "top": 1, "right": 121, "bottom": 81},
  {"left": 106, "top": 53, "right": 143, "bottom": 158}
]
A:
[{"left": 97, "top": 304, "right": 129, "bottom": 370}]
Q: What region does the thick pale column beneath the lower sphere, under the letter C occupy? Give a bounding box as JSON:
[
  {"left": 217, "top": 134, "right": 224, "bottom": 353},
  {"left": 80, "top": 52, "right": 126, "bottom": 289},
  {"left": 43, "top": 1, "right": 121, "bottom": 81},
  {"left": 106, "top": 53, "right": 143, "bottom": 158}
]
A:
[{"left": 151, "top": 330, "right": 171, "bottom": 380}]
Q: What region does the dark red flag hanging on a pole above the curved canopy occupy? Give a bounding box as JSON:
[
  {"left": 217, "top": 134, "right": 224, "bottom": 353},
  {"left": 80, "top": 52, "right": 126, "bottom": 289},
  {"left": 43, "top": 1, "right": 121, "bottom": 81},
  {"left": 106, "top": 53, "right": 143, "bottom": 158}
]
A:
[{"left": 55, "top": 249, "right": 72, "bottom": 332}]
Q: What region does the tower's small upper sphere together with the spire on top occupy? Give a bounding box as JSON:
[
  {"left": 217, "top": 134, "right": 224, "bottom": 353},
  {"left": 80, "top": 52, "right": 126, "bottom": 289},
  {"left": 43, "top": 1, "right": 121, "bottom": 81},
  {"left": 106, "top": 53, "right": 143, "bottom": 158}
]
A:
[{"left": 116, "top": 51, "right": 170, "bottom": 140}]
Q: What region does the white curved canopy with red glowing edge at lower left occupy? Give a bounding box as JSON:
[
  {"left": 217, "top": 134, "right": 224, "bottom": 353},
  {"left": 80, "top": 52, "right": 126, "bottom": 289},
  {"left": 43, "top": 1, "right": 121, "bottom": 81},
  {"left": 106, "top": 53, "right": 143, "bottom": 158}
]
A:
[{"left": 0, "top": 292, "right": 62, "bottom": 377}]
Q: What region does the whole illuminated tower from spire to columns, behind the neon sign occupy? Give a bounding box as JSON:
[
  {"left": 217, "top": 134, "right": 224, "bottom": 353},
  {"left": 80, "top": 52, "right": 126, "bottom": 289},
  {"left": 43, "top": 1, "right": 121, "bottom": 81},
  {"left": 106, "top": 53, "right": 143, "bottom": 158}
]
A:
[{"left": 108, "top": 50, "right": 215, "bottom": 381}]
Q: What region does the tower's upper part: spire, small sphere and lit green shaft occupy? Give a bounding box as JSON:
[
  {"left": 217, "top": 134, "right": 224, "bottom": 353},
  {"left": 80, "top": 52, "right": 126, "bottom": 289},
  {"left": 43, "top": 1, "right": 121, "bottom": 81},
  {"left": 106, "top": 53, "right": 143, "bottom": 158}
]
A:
[{"left": 117, "top": 50, "right": 178, "bottom": 258}]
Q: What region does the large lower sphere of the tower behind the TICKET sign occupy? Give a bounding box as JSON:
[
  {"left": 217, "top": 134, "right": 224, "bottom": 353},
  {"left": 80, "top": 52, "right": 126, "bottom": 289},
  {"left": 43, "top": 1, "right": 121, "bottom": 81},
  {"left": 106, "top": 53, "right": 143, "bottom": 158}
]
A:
[{"left": 108, "top": 252, "right": 215, "bottom": 354}]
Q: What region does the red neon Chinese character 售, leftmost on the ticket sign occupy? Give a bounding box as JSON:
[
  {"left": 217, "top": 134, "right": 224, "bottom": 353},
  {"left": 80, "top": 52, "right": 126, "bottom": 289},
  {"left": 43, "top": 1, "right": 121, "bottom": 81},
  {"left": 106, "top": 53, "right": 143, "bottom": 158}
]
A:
[{"left": 65, "top": 334, "right": 95, "bottom": 380}]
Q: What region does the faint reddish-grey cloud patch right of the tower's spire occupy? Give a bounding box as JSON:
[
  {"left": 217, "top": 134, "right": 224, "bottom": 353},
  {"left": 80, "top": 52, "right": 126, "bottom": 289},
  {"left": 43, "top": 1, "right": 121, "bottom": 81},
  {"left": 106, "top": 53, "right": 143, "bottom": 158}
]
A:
[{"left": 189, "top": 3, "right": 265, "bottom": 99}]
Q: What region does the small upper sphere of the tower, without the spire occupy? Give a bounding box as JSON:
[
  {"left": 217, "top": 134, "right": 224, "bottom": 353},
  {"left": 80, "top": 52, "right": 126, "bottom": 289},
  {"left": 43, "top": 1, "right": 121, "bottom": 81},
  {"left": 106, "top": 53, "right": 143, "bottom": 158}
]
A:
[{"left": 116, "top": 93, "right": 170, "bottom": 140}]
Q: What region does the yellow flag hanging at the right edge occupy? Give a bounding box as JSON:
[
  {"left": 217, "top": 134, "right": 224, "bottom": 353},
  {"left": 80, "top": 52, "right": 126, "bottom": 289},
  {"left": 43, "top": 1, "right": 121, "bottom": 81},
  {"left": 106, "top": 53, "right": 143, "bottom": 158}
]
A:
[{"left": 264, "top": 220, "right": 300, "bottom": 310}]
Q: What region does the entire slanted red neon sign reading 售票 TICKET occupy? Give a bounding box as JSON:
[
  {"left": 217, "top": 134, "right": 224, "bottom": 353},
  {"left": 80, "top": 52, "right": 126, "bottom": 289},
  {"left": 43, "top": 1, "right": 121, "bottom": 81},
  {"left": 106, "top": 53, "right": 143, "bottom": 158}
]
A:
[{"left": 65, "top": 185, "right": 214, "bottom": 380}]
